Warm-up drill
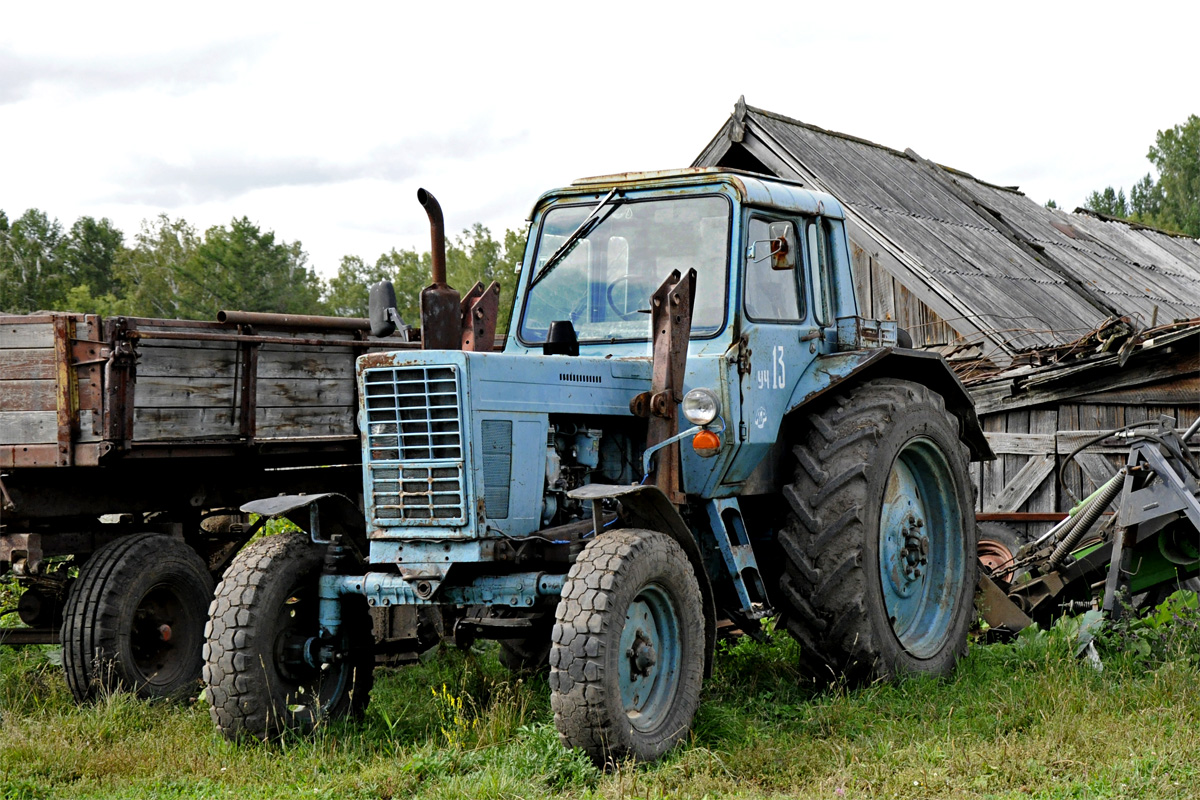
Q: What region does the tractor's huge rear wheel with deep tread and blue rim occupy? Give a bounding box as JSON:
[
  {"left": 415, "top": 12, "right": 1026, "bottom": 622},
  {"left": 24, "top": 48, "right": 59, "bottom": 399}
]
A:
[{"left": 780, "top": 380, "right": 976, "bottom": 684}]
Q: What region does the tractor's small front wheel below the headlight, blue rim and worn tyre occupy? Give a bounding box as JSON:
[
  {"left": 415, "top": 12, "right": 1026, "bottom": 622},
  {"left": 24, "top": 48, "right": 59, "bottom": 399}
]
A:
[{"left": 550, "top": 529, "right": 704, "bottom": 766}]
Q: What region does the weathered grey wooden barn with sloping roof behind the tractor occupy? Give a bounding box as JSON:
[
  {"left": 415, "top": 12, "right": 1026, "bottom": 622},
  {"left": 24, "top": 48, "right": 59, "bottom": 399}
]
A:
[{"left": 694, "top": 100, "right": 1200, "bottom": 535}]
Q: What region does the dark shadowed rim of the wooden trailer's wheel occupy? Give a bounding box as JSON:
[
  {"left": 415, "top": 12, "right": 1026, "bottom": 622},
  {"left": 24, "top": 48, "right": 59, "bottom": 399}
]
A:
[{"left": 130, "top": 584, "right": 196, "bottom": 686}]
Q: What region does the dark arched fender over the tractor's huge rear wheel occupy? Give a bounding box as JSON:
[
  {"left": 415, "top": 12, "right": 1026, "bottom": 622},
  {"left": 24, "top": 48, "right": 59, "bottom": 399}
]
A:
[{"left": 787, "top": 348, "right": 996, "bottom": 461}]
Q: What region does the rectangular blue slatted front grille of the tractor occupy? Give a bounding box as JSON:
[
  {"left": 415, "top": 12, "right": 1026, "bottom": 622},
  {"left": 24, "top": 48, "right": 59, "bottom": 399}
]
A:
[{"left": 362, "top": 367, "right": 467, "bottom": 525}]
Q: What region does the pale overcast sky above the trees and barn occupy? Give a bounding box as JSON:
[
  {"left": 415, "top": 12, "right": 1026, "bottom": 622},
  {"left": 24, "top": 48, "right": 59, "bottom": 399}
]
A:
[{"left": 0, "top": 0, "right": 1200, "bottom": 276}]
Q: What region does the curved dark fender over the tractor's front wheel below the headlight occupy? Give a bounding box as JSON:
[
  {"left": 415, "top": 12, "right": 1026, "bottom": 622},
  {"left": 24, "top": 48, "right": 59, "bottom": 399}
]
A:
[{"left": 568, "top": 483, "right": 716, "bottom": 678}]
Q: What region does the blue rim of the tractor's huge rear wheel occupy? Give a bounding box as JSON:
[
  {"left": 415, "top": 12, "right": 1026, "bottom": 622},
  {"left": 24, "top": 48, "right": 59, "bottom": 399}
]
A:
[{"left": 880, "top": 438, "right": 966, "bottom": 658}]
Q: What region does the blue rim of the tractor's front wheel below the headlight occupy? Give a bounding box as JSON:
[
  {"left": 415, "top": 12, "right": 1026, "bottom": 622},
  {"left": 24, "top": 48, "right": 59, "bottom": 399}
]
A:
[{"left": 618, "top": 584, "right": 680, "bottom": 730}]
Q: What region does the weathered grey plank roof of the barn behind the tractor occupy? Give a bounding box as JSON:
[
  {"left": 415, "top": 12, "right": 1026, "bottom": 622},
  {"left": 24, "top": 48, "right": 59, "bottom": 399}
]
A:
[{"left": 694, "top": 100, "right": 1200, "bottom": 360}]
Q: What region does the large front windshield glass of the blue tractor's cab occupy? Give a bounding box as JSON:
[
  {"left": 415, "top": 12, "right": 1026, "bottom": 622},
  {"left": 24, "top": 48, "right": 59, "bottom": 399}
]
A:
[{"left": 521, "top": 197, "right": 730, "bottom": 344}]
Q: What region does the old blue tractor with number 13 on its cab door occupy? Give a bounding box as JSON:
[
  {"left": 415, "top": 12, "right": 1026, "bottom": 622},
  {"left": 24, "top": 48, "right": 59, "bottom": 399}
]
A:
[{"left": 204, "top": 168, "right": 991, "bottom": 764}]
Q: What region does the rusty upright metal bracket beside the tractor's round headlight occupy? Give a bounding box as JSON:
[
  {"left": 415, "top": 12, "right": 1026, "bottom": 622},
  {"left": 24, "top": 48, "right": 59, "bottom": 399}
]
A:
[{"left": 635, "top": 270, "right": 696, "bottom": 505}]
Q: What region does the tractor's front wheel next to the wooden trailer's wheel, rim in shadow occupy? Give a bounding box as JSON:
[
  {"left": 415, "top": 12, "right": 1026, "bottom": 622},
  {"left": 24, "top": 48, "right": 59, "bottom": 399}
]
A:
[{"left": 204, "top": 533, "right": 374, "bottom": 739}]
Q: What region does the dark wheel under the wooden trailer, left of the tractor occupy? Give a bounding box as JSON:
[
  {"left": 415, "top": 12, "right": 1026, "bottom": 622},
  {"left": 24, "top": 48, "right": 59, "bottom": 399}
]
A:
[{"left": 61, "top": 533, "right": 212, "bottom": 703}]
